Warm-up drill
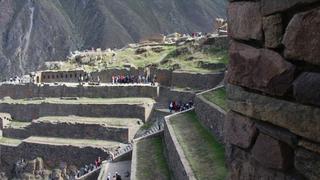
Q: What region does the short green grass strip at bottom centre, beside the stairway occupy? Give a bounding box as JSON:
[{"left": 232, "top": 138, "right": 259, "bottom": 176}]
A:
[{"left": 136, "top": 137, "right": 170, "bottom": 179}]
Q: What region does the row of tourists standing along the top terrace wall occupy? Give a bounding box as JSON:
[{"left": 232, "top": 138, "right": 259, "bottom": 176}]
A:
[{"left": 111, "top": 75, "right": 156, "bottom": 85}]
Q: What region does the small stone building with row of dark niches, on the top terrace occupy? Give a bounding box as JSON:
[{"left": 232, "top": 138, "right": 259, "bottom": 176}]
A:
[{"left": 34, "top": 70, "right": 87, "bottom": 83}]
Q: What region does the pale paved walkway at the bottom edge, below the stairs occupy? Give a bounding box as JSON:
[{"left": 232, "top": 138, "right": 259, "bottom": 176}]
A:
[{"left": 104, "top": 161, "right": 131, "bottom": 180}]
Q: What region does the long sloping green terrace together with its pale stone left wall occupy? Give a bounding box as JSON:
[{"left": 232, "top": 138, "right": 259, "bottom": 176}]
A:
[{"left": 165, "top": 111, "right": 227, "bottom": 179}]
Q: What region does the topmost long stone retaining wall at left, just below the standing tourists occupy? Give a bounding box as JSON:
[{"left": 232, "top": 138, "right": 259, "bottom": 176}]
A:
[{"left": 0, "top": 84, "right": 157, "bottom": 99}]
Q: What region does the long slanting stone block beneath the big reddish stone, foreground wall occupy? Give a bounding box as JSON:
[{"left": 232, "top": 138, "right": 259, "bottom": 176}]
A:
[{"left": 227, "top": 85, "right": 320, "bottom": 142}]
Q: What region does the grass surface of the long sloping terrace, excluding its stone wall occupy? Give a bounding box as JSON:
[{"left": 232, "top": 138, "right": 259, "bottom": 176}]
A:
[{"left": 170, "top": 112, "right": 227, "bottom": 180}]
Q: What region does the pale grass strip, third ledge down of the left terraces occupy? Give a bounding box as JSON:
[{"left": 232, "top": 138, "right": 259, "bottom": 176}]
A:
[{"left": 23, "top": 136, "right": 120, "bottom": 148}]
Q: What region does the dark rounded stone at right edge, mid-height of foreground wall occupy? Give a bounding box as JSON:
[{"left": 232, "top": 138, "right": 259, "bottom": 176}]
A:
[{"left": 293, "top": 72, "right": 320, "bottom": 106}]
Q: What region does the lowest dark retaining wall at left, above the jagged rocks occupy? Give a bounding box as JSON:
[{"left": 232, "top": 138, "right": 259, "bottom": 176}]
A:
[{"left": 0, "top": 143, "right": 108, "bottom": 178}]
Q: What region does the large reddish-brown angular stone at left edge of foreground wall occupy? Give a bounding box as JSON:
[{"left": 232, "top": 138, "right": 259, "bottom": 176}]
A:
[{"left": 227, "top": 42, "right": 295, "bottom": 95}]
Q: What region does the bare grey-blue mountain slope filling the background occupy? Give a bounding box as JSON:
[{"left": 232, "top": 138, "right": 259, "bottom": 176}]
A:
[{"left": 0, "top": 0, "right": 226, "bottom": 79}]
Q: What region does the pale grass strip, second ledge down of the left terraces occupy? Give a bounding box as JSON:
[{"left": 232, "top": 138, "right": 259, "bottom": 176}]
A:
[{"left": 36, "top": 116, "right": 142, "bottom": 127}]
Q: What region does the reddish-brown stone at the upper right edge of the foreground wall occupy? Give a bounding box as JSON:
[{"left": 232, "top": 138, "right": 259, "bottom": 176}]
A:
[{"left": 283, "top": 8, "right": 320, "bottom": 65}]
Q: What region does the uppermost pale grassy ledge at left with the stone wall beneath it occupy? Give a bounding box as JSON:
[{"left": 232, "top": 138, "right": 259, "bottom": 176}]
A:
[{"left": 0, "top": 98, "right": 154, "bottom": 121}]
